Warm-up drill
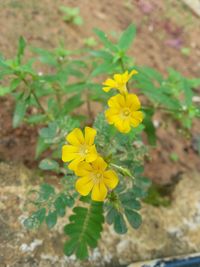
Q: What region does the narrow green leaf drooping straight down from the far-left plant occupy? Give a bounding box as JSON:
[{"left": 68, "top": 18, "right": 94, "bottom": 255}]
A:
[{"left": 12, "top": 99, "right": 27, "bottom": 128}]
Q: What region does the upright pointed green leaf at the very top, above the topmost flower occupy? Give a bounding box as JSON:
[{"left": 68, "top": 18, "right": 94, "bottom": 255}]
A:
[{"left": 118, "top": 24, "right": 136, "bottom": 51}]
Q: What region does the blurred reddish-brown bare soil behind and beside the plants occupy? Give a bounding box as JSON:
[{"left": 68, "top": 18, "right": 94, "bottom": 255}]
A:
[{"left": 0, "top": 0, "right": 200, "bottom": 182}]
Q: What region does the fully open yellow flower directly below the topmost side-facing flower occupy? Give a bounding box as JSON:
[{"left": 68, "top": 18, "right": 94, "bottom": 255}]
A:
[{"left": 105, "top": 94, "right": 143, "bottom": 133}]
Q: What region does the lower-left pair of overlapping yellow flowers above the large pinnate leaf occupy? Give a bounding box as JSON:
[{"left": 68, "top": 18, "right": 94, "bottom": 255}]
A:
[{"left": 62, "top": 127, "right": 119, "bottom": 201}]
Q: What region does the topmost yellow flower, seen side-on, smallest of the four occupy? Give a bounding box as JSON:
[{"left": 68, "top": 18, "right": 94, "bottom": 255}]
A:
[{"left": 103, "top": 70, "right": 138, "bottom": 94}]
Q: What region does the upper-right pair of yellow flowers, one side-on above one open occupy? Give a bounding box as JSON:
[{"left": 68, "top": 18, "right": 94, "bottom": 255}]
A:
[{"left": 103, "top": 70, "right": 143, "bottom": 133}]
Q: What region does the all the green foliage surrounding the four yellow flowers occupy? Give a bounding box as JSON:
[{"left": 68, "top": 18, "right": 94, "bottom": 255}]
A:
[{"left": 0, "top": 24, "right": 200, "bottom": 259}]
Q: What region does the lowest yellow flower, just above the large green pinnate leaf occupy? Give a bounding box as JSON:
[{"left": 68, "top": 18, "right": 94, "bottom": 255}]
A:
[{"left": 75, "top": 157, "right": 119, "bottom": 201}]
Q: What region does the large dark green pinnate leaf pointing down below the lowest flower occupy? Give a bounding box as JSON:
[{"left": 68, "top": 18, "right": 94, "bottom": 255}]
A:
[{"left": 64, "top": 201, "right": 104, "bottom": 259}]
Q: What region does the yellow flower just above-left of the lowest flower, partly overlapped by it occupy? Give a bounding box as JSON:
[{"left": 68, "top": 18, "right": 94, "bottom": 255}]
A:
[{"left": 62, "top": 127, "right": 98, "bottom": 170}]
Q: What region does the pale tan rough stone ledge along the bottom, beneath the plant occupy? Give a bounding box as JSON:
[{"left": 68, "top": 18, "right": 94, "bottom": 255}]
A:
[{"left": 0, "top": 163, "right": 200, "bottom": 267}]
